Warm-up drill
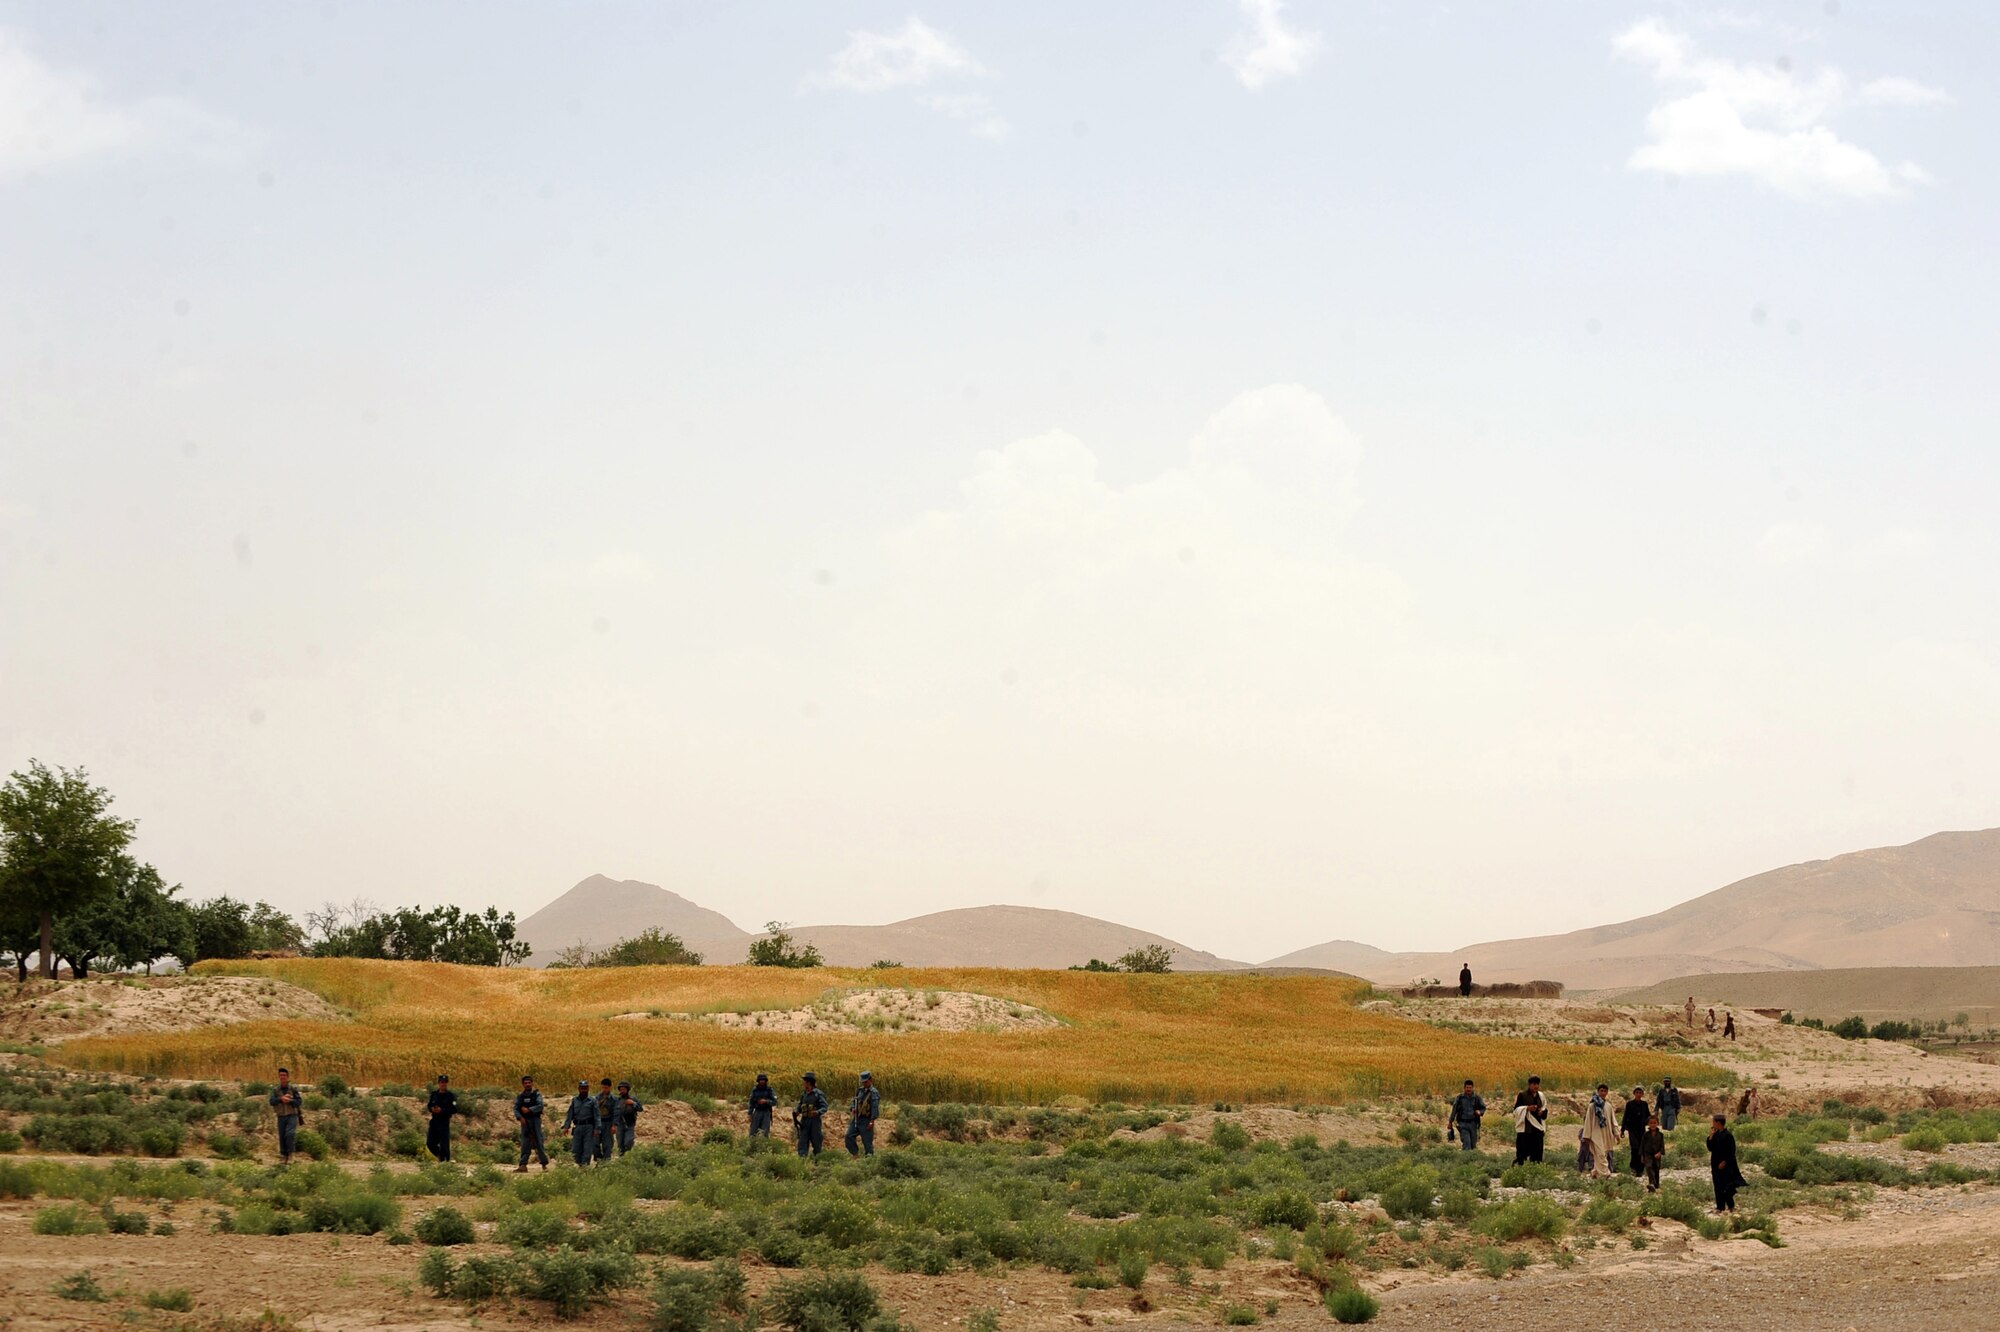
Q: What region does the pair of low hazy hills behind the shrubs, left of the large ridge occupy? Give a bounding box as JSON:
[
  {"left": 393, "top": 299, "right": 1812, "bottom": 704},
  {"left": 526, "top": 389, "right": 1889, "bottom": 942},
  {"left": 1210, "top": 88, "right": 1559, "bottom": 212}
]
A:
[{"left": 518, "top": 874, "right": 1246, "bottom": 972}]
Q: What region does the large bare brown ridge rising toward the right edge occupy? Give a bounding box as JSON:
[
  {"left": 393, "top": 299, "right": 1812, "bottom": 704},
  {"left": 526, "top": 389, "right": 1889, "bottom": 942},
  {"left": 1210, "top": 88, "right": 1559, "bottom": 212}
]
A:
[{"left": 1270, "top": 828, "right": 2000, "bottom": 990}]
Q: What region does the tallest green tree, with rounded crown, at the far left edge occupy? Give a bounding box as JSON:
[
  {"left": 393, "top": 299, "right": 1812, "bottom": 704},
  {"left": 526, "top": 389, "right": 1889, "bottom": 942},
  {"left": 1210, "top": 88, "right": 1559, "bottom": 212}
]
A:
[{"left": 0, "top": 760, "right": 134, "bottom": 978}]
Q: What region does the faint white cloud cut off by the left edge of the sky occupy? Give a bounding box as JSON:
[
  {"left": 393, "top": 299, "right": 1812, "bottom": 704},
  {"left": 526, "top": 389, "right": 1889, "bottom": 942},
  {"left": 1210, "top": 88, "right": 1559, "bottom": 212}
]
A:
[{"left": 0, "top": 28, "right": 244, "bottom": 182}]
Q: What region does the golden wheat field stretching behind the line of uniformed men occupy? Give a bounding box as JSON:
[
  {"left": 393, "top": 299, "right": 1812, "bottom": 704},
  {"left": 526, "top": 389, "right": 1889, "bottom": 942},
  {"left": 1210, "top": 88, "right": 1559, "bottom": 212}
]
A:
[{"left": 60, "top": 960, "right": 1724, "bottom": 1104}]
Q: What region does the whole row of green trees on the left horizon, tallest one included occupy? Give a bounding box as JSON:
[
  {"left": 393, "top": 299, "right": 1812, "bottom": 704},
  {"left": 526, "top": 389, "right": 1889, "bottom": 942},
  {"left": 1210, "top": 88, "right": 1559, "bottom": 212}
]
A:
[{"left": 0, "top": 760, "right": 530, "bottom": 980}]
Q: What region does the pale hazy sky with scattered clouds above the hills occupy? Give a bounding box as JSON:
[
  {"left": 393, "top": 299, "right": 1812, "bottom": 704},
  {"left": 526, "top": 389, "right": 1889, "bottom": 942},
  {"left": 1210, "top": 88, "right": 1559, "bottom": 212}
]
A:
[{"left": 0, "top": 0, "right": 2000, "bottom": 960}]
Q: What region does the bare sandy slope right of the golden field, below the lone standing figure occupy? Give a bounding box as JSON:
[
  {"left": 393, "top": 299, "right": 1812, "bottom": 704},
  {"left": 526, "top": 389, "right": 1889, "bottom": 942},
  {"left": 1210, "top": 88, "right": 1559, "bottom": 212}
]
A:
[{"left": 1366, "top": 996, "right": 2000, "bottom": 1112}]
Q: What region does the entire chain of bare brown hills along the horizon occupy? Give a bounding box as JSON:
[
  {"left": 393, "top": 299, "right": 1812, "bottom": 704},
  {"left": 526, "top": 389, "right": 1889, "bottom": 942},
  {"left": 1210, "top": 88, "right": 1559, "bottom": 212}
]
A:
[{"left": 520, "top": 828, "right": 2000, "bottom": 990}]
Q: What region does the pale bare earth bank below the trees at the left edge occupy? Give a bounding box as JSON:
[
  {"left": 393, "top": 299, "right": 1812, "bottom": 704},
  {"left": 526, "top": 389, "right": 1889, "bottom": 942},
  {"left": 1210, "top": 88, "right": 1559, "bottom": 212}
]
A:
[{"left": 0, "top": 976, "right": 346, "bottom": 1042}]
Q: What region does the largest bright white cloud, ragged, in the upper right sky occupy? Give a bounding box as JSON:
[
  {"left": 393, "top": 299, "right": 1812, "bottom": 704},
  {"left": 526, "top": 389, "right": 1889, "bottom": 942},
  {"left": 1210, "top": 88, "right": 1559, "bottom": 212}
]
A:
[{"left": 1612, "top": 18, "right": 1942, "bottom": 198}]
